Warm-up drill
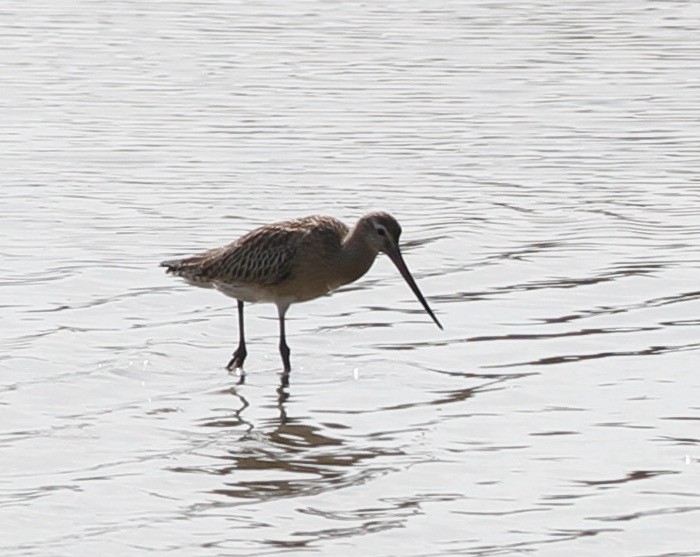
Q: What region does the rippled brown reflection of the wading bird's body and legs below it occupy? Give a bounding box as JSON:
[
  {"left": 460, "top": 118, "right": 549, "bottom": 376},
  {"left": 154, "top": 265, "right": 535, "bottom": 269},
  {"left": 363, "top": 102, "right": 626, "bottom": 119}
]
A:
[{"left": 180, "top": 384, "right": 394, "bottom": 499}]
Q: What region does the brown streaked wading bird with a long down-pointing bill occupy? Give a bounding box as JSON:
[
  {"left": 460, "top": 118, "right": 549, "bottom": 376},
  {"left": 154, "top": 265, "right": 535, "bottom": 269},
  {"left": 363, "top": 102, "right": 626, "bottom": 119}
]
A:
[{"left": 160, "top": 211, "right": 443, "bottom": 385}]
